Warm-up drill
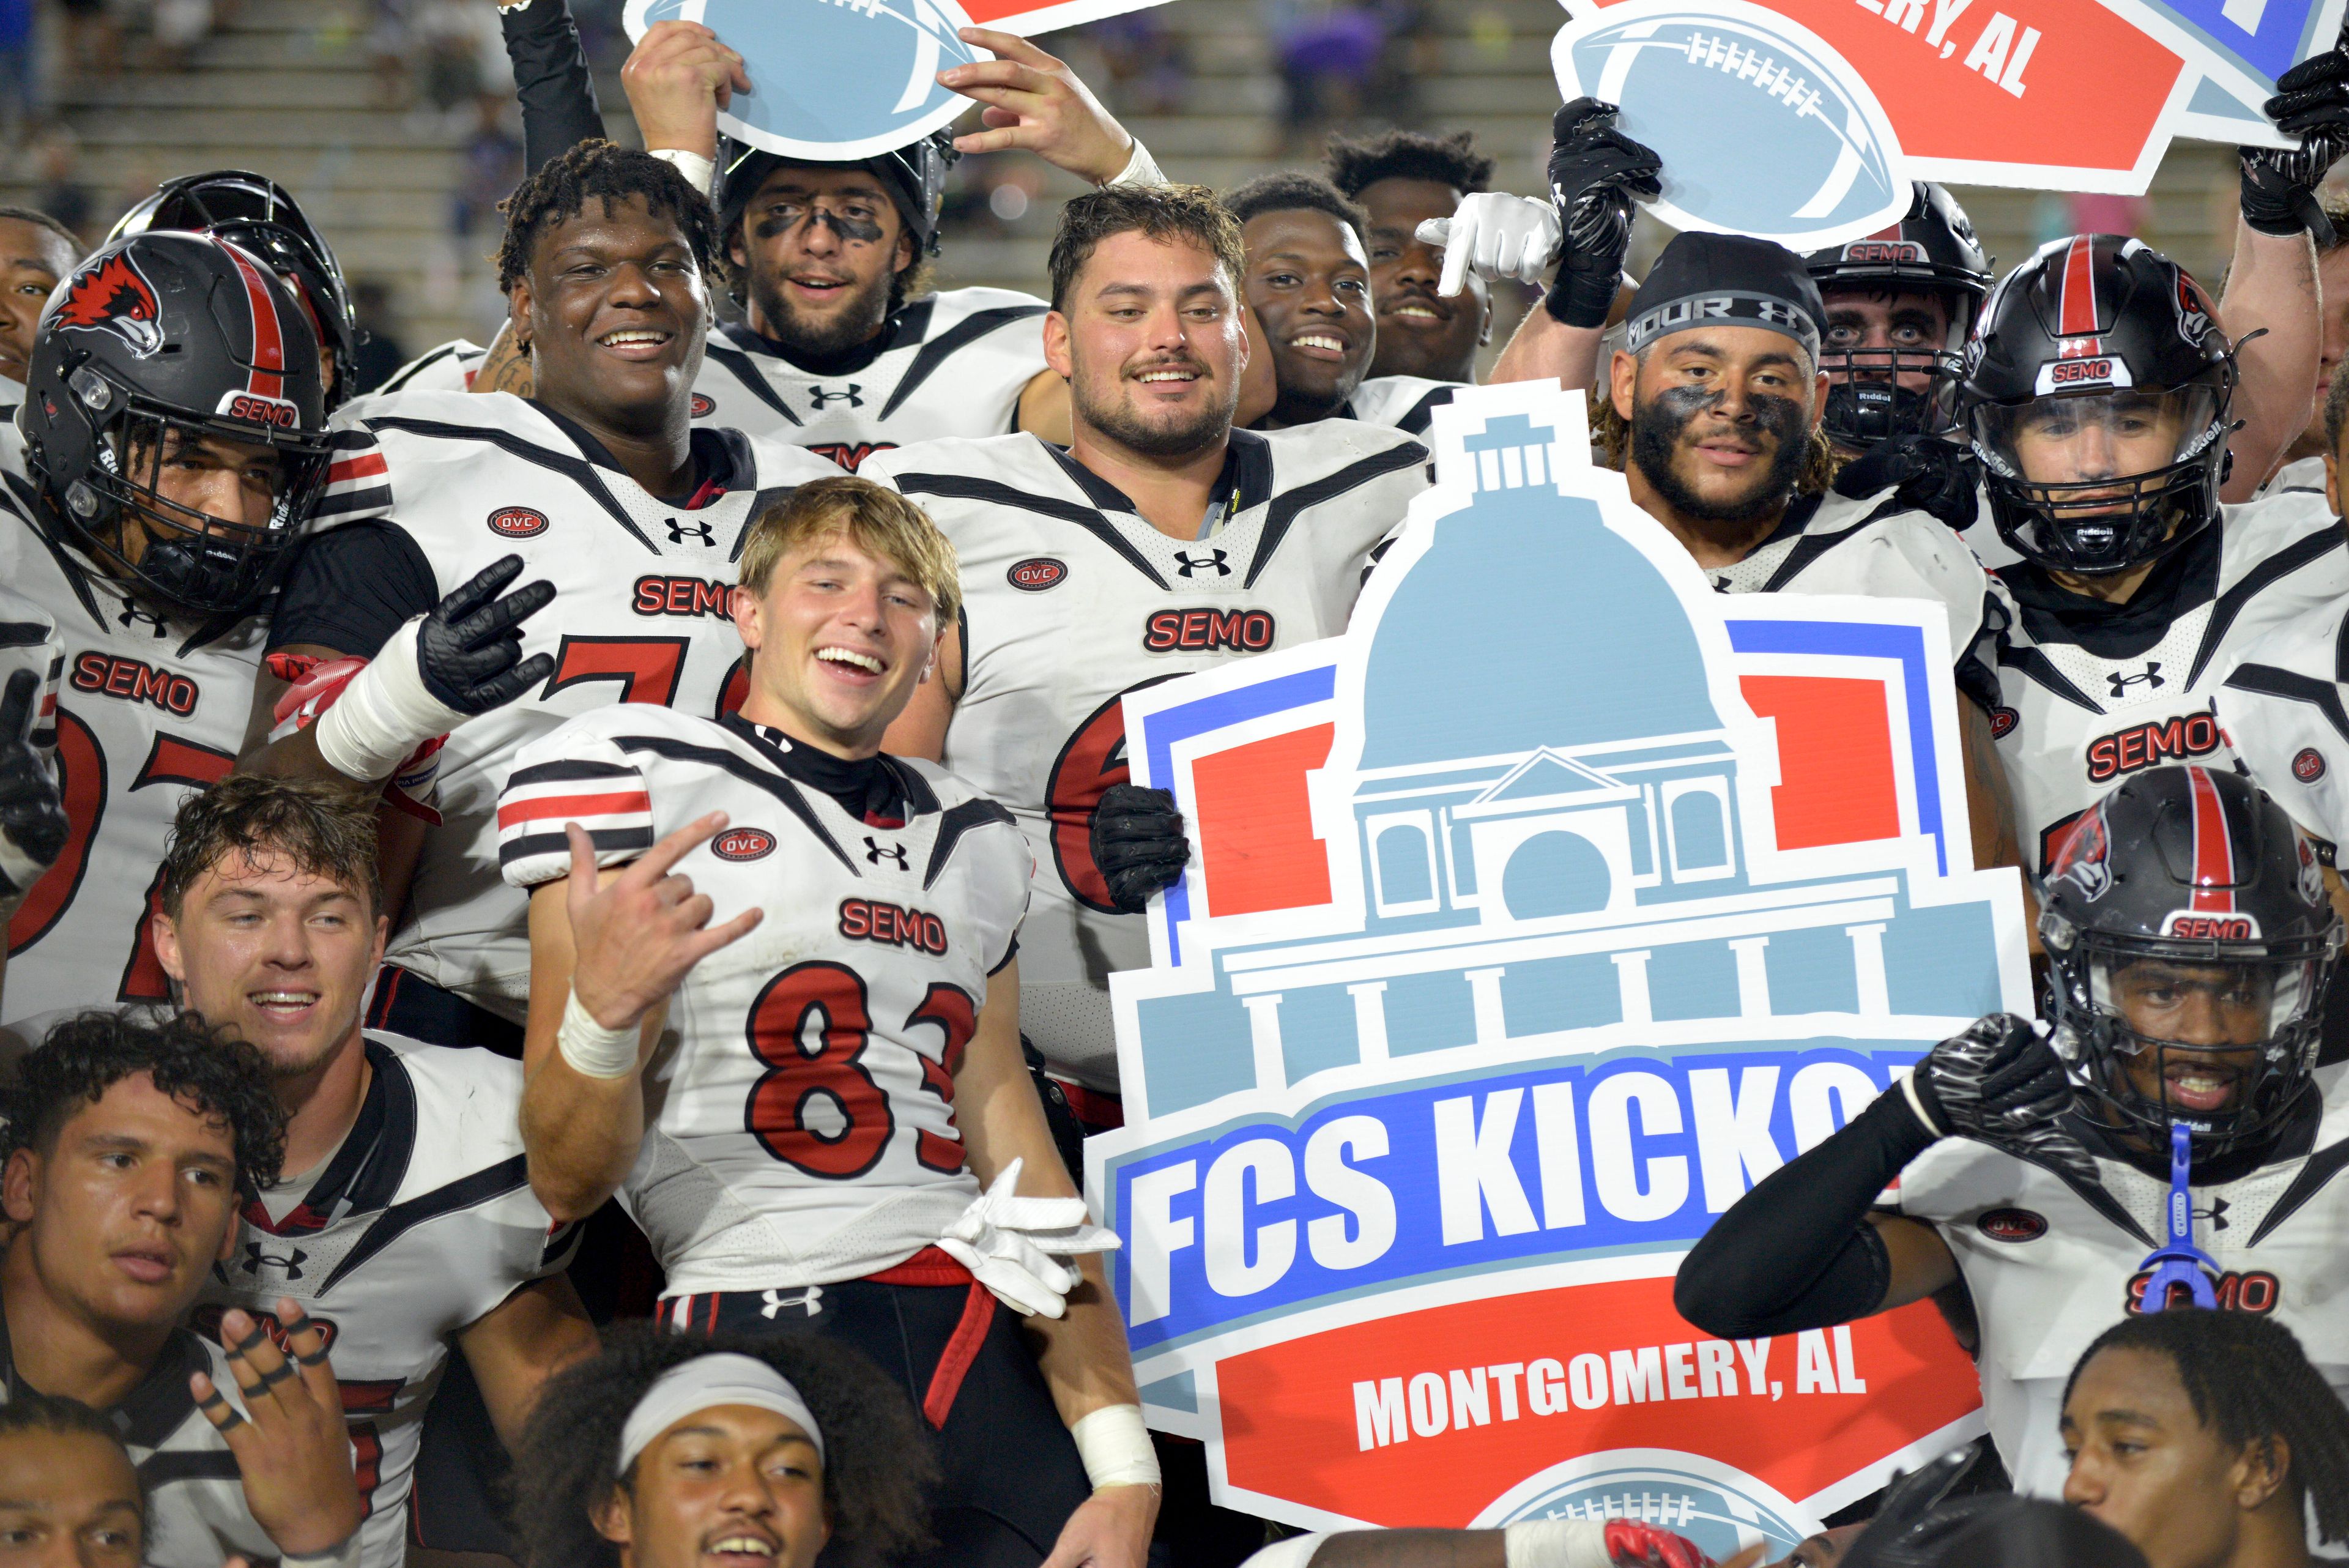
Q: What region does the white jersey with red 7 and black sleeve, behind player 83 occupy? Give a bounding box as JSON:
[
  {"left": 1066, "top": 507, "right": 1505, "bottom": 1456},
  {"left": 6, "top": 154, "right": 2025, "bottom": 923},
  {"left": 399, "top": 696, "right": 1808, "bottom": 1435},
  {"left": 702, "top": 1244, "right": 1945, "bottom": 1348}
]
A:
[{"left": 281, "top": 393, "right": 839, "bottom": 1023}]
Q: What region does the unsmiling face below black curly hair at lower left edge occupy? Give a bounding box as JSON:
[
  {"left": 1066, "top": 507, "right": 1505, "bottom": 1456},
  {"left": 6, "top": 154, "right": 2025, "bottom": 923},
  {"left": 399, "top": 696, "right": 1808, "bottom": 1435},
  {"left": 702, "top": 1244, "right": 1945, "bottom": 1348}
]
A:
[{"left": 0, "top": 1072, "right": 237, "bottom": 1333}]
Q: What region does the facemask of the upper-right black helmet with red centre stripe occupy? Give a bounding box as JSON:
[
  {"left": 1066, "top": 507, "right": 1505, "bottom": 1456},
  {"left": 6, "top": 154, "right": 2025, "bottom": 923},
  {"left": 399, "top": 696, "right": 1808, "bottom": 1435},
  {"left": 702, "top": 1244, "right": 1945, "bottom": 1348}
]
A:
[{"left": 1966, "top": 381, "right": 2232, "bottom": 576}]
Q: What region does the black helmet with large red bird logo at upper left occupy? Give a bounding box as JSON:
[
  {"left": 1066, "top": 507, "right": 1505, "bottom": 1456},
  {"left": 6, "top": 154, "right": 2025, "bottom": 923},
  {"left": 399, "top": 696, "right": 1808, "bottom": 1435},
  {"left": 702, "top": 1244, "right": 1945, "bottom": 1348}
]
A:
[{"left": 17, "top": 231, "right": 327, "bottom": 616}]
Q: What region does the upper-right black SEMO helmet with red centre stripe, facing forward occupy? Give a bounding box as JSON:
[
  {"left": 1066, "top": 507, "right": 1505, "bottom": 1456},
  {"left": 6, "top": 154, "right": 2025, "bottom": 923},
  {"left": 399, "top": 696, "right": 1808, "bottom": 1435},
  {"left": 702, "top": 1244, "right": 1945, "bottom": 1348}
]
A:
[{"left": 1959, "top": 235, "right": 2234, "bottom": 576}]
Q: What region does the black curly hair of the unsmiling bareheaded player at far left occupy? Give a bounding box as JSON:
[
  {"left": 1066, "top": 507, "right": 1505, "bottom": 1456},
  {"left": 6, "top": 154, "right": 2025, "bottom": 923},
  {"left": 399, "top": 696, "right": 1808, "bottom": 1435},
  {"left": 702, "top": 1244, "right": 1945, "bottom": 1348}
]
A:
[{"left": 0, "top": 1013, "right": 286, "bottom": 1197}]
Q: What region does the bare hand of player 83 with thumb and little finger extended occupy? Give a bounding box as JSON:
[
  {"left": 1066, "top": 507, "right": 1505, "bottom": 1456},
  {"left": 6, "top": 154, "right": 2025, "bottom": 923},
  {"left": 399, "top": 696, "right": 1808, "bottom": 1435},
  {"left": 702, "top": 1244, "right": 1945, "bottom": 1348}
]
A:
[{"left": 564, "top": 811, "right": 766, "bottom": 1030}]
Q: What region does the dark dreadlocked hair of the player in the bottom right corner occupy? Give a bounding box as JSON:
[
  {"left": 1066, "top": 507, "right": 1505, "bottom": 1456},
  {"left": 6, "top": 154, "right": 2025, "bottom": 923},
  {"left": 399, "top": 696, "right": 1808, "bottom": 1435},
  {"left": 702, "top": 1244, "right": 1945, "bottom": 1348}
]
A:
[{"left": 2063, "top": 1307, "right": 2349, "bottom": 1542}]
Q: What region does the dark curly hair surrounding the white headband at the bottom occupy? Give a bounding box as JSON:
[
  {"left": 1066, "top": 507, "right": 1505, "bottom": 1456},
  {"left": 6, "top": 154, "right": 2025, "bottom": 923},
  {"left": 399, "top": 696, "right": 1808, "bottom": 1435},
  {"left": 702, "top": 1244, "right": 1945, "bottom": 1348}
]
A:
[{"left": 512, "top": 1323, "right": 935, "bottom": 1568}]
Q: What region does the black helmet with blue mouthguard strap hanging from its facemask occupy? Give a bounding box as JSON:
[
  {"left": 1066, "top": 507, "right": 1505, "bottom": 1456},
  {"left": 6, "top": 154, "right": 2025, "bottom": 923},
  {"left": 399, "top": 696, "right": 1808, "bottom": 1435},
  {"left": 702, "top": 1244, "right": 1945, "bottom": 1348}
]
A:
[{"left": 2039, "top": 767, "right": 2342, "bottom": 1159}]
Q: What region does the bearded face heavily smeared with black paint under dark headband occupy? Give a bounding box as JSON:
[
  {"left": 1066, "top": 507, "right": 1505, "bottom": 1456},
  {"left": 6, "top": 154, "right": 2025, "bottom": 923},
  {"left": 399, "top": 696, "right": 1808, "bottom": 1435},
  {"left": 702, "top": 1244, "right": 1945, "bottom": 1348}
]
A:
[{"left": 1611, "top": 327, "right": 1825, "bottom": 524}]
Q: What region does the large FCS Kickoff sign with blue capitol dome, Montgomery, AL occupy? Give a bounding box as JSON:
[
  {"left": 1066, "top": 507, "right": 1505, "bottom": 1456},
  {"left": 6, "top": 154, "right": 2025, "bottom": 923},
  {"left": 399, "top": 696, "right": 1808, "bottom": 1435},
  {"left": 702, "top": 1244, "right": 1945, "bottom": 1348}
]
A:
[{"left": 1085, "top": 383, "right": 2030, "bottom": 1556}]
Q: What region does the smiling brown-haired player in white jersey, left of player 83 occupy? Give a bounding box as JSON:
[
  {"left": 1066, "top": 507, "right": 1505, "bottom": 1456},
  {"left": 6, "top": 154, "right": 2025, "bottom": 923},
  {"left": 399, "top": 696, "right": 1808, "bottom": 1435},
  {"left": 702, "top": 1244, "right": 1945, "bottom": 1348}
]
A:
[{"left": 141, "top": 773, "right": 596, "bottom": 1568}]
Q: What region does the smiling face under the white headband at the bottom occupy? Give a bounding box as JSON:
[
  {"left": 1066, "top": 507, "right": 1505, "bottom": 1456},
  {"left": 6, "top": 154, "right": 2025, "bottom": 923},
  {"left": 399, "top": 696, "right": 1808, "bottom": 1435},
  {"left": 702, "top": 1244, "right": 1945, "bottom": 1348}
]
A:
[{"left": 596, "top": 1406, "right": 831, "bottom": 1568}]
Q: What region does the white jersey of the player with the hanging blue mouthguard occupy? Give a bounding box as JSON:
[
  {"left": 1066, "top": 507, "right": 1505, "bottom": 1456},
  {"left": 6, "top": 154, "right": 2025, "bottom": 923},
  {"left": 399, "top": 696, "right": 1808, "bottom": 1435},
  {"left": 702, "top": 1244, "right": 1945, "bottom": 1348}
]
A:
[{"left": 1896, "top": 1068, "right": 2349, "bottom": 1498}]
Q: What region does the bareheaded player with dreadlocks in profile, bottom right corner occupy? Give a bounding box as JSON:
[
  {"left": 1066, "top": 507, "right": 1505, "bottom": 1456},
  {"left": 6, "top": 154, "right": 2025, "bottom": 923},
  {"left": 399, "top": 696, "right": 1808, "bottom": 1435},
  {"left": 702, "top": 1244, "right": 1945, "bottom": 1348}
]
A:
[{"left": 2063, "top": 1312, "right": 2349, "bottom": 1568}]
